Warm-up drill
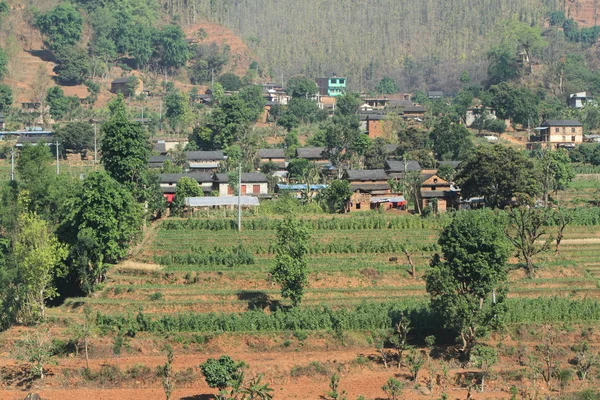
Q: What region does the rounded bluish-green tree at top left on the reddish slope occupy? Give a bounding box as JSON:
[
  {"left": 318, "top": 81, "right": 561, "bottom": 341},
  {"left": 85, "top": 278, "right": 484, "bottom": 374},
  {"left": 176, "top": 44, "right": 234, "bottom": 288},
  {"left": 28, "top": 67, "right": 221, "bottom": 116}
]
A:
[{"left": 35, "top": 3, "right": 83, "bottom": 50}]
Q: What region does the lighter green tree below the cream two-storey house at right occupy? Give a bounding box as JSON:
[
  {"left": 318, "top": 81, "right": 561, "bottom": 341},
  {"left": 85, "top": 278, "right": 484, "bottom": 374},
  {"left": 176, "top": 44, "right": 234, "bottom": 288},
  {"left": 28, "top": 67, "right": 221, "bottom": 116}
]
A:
[{"left": 536, "top": 149, "right": 575, "bottom": 207}]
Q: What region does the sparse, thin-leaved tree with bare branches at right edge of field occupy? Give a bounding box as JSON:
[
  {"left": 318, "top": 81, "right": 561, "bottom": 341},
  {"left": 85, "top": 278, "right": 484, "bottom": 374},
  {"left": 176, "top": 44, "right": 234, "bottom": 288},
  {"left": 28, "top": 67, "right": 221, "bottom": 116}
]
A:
[{"left": 506, "top": 206, "right": 553, "bottom": 278}]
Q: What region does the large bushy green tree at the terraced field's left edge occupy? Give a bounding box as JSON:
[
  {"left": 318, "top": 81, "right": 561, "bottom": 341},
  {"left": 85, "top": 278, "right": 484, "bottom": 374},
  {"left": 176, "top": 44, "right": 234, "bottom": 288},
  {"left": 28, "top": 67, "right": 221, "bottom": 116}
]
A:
[{"left": 59, "top": 172, "right": 143, "bottom": 293}]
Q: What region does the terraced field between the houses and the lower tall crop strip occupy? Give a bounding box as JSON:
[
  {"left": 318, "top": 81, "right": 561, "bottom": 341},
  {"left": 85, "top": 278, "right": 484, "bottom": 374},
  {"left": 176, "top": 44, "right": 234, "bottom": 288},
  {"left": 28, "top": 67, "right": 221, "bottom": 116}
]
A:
[{"left": 55, "top": 217, "right": 600, "bottom": 315}]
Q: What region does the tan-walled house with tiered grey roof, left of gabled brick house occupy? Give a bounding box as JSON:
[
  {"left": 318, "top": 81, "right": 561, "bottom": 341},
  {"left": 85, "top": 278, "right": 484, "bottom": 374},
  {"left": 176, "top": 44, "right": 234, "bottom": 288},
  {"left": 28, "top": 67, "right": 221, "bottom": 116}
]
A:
[{"left": 343, "top": 169, "right": 391, "bottom": 212}]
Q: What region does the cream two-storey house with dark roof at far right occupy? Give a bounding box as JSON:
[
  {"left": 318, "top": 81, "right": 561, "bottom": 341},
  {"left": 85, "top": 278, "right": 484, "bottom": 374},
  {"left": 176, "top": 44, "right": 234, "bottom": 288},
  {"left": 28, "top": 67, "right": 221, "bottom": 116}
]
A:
[{"left": 527, "top": 119, "right": 583, "bottom": 149}]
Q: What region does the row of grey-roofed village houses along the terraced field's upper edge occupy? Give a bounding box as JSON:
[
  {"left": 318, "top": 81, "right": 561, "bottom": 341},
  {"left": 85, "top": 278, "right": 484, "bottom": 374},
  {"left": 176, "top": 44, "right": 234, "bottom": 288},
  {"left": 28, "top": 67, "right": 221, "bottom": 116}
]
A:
[{"left": 150, "top": 143, "right": 460, "bottom": 212}]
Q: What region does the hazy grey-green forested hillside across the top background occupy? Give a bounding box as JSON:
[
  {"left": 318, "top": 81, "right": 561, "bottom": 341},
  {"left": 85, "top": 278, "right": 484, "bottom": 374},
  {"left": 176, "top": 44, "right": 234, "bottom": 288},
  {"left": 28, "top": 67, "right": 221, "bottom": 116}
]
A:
[{"left": 161, "top": 0, "right": 564, "bottom": 90}]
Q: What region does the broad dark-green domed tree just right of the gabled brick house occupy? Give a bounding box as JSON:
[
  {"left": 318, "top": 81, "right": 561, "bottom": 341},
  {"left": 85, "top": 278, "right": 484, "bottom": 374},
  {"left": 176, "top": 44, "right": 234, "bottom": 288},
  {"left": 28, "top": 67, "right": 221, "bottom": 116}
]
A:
[{"left": 456, "top": 145, "right": 539, "bottom": 208}]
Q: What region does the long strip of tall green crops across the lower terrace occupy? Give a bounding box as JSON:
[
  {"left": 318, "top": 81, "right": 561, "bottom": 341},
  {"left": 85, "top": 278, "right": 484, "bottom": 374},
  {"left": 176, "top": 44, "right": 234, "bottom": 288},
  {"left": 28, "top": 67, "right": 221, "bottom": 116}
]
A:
[{"left": 96, "top": 297, "right": 600, "bottom": 335}]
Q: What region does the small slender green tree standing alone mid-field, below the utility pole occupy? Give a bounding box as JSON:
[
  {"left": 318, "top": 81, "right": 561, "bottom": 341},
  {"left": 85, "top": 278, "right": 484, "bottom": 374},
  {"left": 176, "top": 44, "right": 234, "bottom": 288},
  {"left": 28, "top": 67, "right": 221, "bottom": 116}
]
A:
[{"left": 271, "top": 215, "right": 310, "bottom": 307}]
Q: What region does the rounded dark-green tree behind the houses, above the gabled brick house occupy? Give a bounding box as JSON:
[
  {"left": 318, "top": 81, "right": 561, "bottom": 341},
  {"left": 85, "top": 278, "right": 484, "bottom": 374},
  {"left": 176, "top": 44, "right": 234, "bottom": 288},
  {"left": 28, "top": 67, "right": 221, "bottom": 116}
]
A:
[{"left": 430, "top": 117, "right": 474, "bottom": 160}]
